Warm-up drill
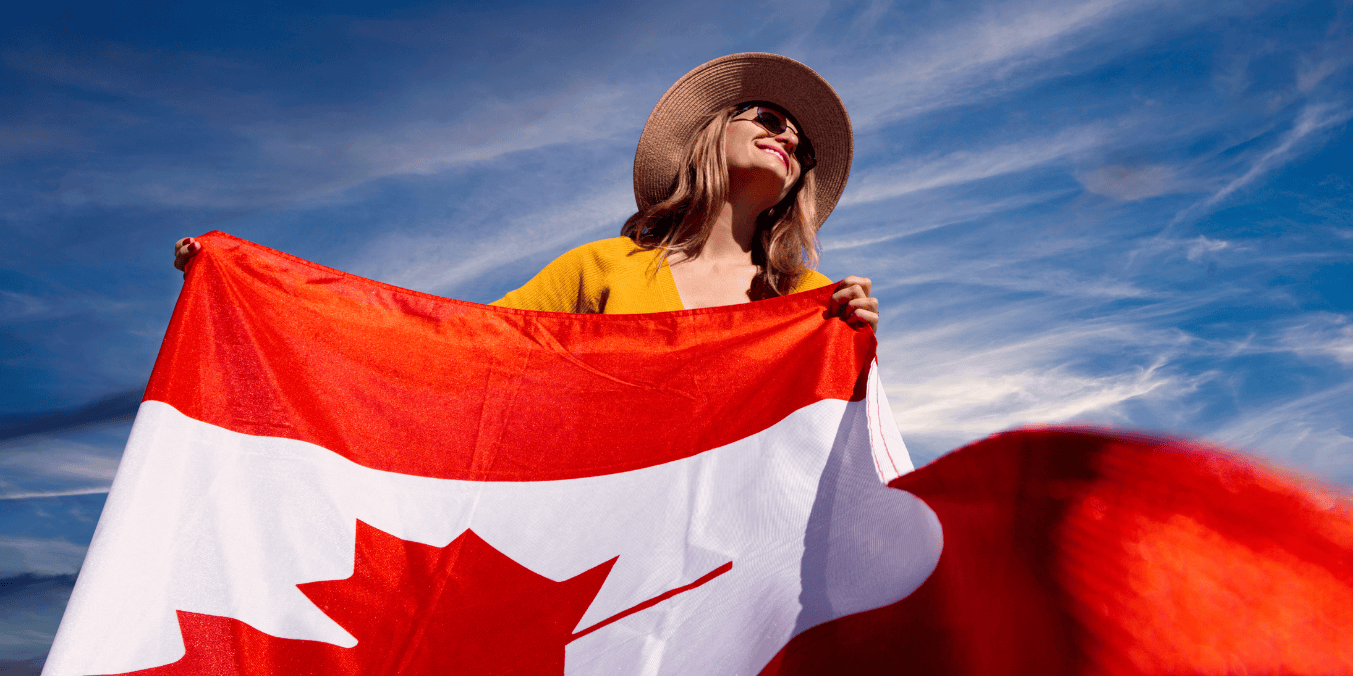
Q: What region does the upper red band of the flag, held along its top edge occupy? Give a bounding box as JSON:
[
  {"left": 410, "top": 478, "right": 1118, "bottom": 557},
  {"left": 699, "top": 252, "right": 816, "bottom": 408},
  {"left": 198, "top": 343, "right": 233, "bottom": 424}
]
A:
[{"left": 146, "top": 233, "right": 875, "bottom": 481}]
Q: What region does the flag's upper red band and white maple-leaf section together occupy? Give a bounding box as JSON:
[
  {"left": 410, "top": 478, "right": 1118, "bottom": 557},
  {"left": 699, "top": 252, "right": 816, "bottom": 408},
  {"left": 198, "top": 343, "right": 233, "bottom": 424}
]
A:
[{"left": 46, "top": 234, "right": 942, "bottom": 675}]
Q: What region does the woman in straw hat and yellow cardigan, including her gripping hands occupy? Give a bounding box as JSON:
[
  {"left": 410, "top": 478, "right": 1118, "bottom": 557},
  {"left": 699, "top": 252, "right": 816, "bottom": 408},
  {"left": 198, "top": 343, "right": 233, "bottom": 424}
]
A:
[{"left": 175, "top": 53, "right": 878, "bottom": 329}]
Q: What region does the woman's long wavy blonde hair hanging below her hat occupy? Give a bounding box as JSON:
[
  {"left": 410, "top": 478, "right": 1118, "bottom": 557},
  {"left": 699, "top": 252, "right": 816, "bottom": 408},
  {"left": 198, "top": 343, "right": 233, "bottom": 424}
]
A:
[{"left": 620, "top": 105, "right": 817, "bottom": 299}]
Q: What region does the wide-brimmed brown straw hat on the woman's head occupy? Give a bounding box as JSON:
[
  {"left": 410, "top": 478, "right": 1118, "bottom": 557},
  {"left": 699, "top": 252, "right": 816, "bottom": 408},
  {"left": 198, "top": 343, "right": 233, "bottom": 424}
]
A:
[{"left": 635, "top": 51, "right": 854, "bottom": 226}]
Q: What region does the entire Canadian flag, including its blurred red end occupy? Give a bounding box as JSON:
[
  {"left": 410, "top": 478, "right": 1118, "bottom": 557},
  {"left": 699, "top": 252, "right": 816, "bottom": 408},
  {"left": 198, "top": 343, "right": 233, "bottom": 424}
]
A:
[{"left": 43, "top": 233, "right": 1353, "bottom": 676}]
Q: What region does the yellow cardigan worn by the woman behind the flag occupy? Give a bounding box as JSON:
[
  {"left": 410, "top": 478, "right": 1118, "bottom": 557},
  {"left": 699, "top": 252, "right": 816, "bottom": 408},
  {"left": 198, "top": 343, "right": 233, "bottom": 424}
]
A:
[{"left": 491, "top": 237, "right": 832, "bottom": 315}]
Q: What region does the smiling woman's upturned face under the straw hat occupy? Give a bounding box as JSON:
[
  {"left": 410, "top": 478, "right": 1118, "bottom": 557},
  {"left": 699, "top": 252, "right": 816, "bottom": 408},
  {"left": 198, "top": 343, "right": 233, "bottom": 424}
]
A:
[{"left": 724, "top": 107, "right": 801, "bottom": 208}]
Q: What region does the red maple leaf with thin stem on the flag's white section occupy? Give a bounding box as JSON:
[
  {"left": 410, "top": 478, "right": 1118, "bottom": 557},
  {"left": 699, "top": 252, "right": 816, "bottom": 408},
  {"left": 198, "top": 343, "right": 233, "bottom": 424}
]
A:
[{"left": 95, "top": 521, "right": 619, "bottom": 676}]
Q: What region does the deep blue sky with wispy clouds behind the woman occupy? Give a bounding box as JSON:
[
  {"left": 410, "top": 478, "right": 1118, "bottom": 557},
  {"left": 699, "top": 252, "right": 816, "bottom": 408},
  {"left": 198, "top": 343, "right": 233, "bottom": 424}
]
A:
[{"left": 0, "top": 0, "right": 1353, "bottom": 669}]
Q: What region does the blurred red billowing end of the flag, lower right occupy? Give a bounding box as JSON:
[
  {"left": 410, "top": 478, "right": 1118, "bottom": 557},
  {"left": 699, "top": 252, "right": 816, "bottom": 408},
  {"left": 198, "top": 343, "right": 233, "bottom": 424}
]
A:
[{"left": 769, "top": 427, "right": 1353, "bottom": 676}]
